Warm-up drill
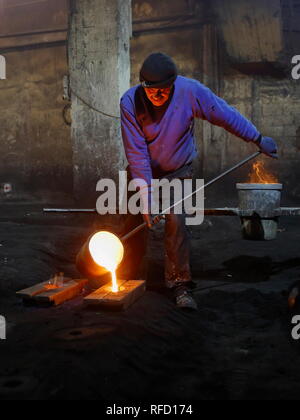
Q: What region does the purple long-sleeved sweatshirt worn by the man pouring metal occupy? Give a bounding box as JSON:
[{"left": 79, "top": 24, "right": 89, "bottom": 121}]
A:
[{"left": 121, "top": 76, "right": 260, "bottom": 185}]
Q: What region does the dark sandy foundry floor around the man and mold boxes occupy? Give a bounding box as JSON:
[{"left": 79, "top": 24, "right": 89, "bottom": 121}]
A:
[{"left": 0, "top": 203, "right": 300, "bottom": 401}]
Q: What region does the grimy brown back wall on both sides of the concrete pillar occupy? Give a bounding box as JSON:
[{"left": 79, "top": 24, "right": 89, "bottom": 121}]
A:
[{"left": 0, "top": 0, "right": 300, "bottom": 201}]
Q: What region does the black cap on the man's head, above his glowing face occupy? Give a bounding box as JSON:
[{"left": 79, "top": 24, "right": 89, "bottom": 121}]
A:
[{"left": 140, "top": 53, "right": 178, "bottom": 88}]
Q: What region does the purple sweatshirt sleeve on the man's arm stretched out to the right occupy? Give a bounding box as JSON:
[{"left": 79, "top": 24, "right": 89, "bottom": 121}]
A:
[{"left": 194, "top": 83, "right": 260, "bottom": 142}]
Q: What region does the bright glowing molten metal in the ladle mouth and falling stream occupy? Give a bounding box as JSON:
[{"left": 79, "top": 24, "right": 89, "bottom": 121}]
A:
[{"left": 89, "top": 232, "right": 124, "bottom": 293}]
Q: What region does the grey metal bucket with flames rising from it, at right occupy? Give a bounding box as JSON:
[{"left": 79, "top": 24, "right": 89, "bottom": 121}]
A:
[{"left": 237, "top": 184, "right": 282, "bottom": 241}]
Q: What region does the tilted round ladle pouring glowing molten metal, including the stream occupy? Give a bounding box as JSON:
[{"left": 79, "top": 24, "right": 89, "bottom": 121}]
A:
[{"left": 76, "top": 231, "right": 124, "bottom": 291}]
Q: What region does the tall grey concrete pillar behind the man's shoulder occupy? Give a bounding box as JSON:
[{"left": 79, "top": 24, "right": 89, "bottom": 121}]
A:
[{"left": 69, "top": 0, "right": 132, "bottom": 205}]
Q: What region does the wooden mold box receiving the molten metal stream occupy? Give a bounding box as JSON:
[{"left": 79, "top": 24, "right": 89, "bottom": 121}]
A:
[{"left": 84, "top": 280, "right": 146, "bottom": 310}]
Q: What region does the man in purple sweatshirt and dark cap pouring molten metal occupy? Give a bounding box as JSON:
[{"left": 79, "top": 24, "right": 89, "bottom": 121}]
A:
[{"left": 120, "top": 52, "right": 278, "bottom": 309}]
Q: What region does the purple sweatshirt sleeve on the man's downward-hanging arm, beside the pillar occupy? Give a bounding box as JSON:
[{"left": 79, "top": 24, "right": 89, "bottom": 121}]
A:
[{"left": 121, "top": 102, "right": 152, "bottom": 186}]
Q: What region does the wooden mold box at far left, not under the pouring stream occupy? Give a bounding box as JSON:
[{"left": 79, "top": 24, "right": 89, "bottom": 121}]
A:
[{"left": 17, "top": 278, "right": 88, "bottom": 306}]
